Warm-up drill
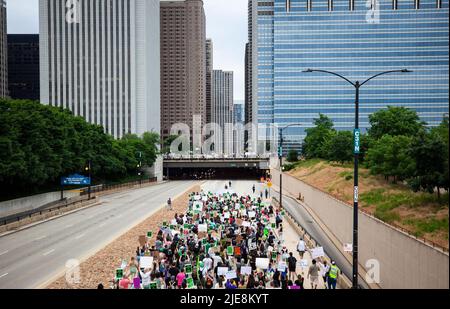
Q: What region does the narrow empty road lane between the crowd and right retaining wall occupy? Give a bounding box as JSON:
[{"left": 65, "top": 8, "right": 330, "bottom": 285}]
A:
[{"left": 274, "top": 190, "right": 369, "bottom": 289}]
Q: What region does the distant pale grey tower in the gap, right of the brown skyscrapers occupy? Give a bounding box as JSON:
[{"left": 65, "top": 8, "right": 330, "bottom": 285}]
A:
[{"left": 211, "top": 70, "right": 234, "bottom": 154}]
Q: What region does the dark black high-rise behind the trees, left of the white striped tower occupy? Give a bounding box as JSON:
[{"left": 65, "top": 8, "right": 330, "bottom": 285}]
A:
[{"left": 8, "top": 34, "right": 40, "bottom": 101}]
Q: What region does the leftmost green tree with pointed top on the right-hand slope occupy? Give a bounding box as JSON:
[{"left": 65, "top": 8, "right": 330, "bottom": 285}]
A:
[{"left": 302, "top": 114, "right": 335, "bottom": 159}]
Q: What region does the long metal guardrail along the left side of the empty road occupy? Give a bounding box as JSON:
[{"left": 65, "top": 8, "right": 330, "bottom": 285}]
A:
[{"left": 0, "top": 178, "right": 157, "bottom": 226}]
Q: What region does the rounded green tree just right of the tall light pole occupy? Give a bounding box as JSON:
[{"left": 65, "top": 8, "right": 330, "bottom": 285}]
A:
[{"left": 367, "top": 135, "right": 415, "bottom": 183}]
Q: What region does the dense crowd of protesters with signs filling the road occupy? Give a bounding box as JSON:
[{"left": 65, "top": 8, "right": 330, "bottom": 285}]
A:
[{"left": 113, "top": 182, "right": 335, "bottom": 289}]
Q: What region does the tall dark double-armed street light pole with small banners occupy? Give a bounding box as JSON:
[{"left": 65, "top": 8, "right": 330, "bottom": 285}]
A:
[{"left": 303, "top": 69, "right": 412, "bottom": 289}]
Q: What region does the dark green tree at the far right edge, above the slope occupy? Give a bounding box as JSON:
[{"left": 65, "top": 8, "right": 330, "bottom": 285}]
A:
[{"left": 410, "top": 131, "right": 449, "bottom": 198}]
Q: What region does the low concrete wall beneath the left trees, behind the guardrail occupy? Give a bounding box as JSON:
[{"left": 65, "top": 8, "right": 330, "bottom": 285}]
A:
[{"left": 0, "top": 191, "right": 80, "bottom": 218}]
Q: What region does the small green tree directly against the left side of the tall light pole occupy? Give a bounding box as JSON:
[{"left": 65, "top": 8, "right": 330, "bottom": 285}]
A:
[{"left": 324, "top": 131, "right": 353, "bottom": 163}]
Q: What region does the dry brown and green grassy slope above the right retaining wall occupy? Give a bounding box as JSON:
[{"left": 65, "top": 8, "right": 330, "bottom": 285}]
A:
[{"left": 288, "top": 160, "right": 449, "bottom": 249}]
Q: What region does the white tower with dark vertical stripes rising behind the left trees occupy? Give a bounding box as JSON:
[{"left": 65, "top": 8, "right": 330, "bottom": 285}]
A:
[{"left": 39, "top": 0, "right": 160, "bottom": 138}]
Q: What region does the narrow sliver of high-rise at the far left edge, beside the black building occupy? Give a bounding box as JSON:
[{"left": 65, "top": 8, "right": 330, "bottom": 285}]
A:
[{"left": 0, "top": 0, "right": 8, "bottom": 98}]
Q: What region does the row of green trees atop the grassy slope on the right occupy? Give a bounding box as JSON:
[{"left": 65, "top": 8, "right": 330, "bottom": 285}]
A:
[{"left": 302, "top": 107, "right": 449, "bottom": 194}]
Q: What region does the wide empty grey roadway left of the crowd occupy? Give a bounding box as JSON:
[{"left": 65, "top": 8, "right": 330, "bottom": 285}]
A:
[{"left": 0, "top": 181, "right": 196, "bottom": 289}]
